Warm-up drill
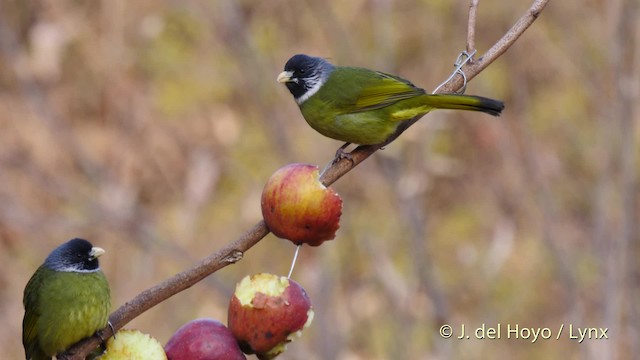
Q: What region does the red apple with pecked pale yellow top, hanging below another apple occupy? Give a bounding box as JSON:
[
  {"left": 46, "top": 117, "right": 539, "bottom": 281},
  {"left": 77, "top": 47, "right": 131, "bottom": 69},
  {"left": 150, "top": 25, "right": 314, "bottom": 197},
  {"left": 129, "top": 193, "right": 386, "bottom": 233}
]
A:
[{"left": 229, "top": 274, "right": 313, "bottom": 359}]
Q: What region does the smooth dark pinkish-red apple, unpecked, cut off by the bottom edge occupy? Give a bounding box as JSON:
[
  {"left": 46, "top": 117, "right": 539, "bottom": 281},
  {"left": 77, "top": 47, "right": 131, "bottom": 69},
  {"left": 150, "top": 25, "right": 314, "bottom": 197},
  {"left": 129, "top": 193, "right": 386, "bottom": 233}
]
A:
[{"left": 164, "top": 318, "right": 246, "bottom": 360}]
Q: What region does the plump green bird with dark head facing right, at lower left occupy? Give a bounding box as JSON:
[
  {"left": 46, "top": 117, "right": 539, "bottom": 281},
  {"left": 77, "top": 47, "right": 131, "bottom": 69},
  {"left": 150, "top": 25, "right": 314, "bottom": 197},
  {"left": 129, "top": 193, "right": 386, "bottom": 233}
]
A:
[{"left": 22, "top": 239, "right": 111, "bottom": 360}]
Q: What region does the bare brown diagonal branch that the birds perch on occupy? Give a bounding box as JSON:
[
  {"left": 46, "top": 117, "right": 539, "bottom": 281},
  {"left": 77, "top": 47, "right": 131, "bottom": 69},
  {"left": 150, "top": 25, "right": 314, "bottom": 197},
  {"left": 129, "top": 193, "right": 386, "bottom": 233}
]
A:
[{"left": 58, "top": 0, "right": 549, "bottom": 360}]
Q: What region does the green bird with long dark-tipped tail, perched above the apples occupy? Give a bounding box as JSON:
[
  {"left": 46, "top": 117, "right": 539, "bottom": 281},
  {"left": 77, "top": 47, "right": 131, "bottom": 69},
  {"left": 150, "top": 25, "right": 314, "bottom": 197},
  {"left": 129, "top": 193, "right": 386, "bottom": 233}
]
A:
[{"left": 277, "top": 54, "right": 504, "bottom": 146}]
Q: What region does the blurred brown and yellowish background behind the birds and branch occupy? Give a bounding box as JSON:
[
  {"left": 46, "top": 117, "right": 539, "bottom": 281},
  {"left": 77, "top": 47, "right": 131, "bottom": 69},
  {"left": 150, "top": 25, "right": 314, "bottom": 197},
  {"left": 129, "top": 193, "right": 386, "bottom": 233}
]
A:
[{"left": 0, "top": 0, "right": 640, "bottom": 360}]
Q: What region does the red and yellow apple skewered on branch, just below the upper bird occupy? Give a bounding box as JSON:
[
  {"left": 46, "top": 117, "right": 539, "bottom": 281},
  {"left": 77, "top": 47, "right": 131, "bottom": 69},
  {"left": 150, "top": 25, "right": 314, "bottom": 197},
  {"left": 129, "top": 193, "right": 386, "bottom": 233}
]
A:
[{"left": 261, "top": 163, "right": 342, "bottom": 246}]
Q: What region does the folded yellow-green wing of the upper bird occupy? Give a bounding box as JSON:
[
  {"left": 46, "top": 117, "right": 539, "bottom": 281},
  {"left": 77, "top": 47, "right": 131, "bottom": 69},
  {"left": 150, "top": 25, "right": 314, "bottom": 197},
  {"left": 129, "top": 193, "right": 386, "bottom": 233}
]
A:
[{"left": 344, "top": 70, "right": 425, "bottom": 111}]
